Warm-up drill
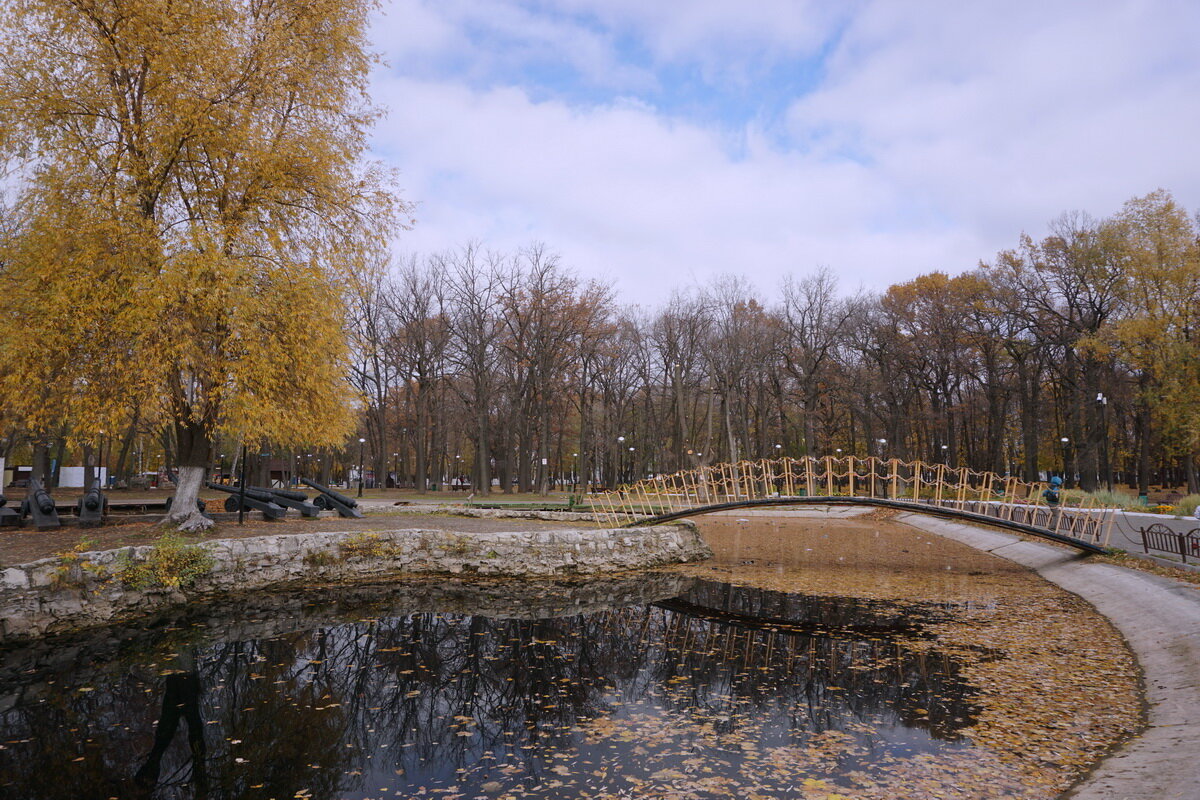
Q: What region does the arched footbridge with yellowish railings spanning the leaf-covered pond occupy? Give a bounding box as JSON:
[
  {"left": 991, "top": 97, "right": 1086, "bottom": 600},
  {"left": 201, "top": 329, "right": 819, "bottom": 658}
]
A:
[{"left": 590, "top": 456, "right": 1114, "bottom": 553}]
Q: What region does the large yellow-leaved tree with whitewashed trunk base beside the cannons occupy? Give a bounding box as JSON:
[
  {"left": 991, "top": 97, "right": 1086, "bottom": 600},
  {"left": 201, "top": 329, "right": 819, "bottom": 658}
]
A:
[{"left": 0, "top": 0, "right": 406, "bottom": 529}]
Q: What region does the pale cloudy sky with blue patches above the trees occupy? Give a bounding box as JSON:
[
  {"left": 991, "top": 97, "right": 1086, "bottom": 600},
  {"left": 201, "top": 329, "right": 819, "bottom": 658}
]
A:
[{"left": 372, "top": 0, "right": 1200, "bottom": 303}]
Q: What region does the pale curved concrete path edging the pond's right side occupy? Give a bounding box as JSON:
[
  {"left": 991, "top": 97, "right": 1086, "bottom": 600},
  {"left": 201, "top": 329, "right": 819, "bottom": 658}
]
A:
[{"left": 896, "top": 513, "right": 1200, "bottom": 800}]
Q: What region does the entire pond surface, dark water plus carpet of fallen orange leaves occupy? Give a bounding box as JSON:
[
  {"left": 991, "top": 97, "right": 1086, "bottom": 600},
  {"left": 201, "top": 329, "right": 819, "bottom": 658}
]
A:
[{"left": 0, "top": 518, "right": 1138, "bottom": 800}]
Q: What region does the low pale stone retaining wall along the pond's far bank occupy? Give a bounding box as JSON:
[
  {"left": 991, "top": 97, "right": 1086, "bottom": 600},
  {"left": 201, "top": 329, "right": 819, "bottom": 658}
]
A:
[{"left": 0, "top": 524, "right": 712, "bottom": 643}]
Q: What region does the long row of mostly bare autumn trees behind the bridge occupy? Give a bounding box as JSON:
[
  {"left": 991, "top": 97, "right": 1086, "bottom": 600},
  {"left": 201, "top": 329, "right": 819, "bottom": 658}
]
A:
[{"left": 8, "top": 191, "right": 1200, "bottom": 492}]
